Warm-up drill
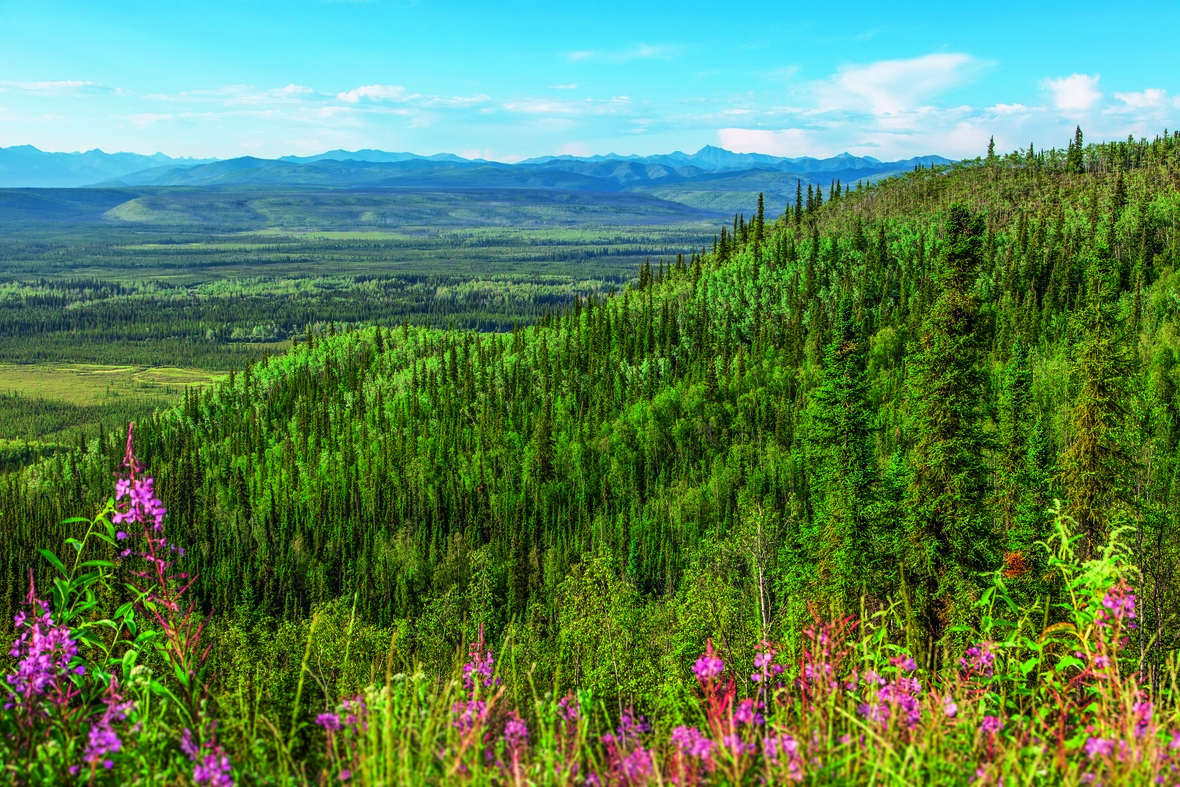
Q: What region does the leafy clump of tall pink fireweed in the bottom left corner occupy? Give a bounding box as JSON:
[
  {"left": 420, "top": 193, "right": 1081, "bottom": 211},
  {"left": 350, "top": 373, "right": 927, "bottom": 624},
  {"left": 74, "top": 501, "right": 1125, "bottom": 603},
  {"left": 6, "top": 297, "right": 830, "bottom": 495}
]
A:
[{"left": 0, "top": 425, "right": 234, "bottom": 787}]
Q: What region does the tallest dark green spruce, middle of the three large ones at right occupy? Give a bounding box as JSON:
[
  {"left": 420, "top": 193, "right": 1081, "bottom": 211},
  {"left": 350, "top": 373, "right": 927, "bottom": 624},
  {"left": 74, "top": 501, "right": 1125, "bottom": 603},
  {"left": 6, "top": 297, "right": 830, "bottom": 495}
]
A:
[{"left": 899, "top": 205, "right": 999, "bottom": 667}]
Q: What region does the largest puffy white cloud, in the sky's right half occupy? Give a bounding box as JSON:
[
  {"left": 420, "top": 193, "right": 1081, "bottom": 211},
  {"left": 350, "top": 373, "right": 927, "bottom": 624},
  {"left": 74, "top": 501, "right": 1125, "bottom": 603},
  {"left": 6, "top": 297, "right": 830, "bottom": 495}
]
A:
[{"left": 814, "top": 53, "right": 982, "bottom": 114}]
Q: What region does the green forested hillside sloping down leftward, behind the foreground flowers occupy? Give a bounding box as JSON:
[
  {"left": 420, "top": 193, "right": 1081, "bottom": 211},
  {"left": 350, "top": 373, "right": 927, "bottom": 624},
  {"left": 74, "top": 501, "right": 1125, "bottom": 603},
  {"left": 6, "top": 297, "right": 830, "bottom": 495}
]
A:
[{"left": 0, "top": 132, "right": 1180, "bottom": 703}]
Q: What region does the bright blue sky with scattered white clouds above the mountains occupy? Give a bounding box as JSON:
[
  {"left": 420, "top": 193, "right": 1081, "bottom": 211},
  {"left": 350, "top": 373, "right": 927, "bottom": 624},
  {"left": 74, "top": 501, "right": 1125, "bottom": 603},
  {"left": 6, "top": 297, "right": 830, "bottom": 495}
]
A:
[{"left": 0, "top": 0, "right": 1180, "bottom": 160}]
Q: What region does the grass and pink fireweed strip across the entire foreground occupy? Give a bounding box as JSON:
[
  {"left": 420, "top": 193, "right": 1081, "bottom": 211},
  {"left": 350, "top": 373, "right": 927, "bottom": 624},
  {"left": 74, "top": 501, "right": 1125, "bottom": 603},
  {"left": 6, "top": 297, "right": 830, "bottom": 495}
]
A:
[{"left": 0, "top": 438, "right": 1180, "bottom": 787}]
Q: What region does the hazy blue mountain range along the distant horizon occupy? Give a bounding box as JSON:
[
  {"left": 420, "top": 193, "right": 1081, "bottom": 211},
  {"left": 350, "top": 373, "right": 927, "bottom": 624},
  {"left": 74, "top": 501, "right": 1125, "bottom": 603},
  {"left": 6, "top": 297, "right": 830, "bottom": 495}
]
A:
[{"left": 0, "top": 145, "right": 950, "bottom": 211}]
